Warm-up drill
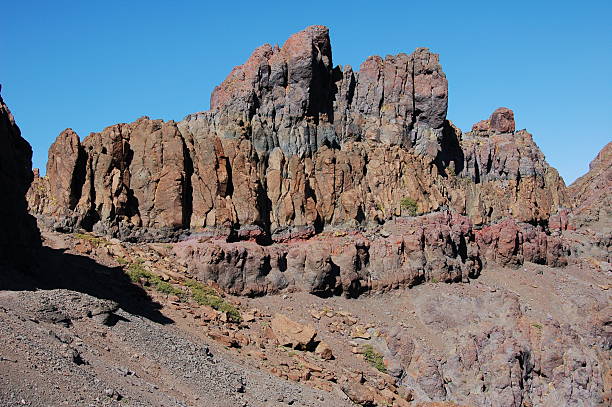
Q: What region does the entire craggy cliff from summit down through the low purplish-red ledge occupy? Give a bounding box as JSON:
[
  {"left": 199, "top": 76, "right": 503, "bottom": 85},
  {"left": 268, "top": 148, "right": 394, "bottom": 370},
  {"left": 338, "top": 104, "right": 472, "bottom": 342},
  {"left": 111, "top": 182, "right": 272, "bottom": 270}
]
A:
[{"left": 23, "top": 26, "right": 568, "bottom": 296}]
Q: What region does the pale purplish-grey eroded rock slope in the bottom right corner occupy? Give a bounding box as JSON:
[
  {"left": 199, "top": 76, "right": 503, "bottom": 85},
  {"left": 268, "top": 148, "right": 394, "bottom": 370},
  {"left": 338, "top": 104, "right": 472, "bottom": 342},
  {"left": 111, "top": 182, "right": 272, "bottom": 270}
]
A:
[{"left": 383, "top": 292, "right": 606, "bottom": 407}]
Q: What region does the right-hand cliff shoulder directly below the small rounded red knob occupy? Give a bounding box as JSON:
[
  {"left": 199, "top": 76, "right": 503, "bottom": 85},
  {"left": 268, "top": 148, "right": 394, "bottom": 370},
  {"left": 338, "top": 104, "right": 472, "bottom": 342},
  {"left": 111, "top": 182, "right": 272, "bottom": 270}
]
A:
[{"left": 457, "top": 126, "right": 569, "bottom": 224}]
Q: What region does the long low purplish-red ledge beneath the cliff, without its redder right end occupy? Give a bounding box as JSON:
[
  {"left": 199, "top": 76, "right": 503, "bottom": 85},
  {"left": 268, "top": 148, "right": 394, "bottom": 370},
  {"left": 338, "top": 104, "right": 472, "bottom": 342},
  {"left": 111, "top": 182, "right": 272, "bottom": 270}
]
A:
[{"left": 174, "top": 212, "right": 482, "bottom": 296}]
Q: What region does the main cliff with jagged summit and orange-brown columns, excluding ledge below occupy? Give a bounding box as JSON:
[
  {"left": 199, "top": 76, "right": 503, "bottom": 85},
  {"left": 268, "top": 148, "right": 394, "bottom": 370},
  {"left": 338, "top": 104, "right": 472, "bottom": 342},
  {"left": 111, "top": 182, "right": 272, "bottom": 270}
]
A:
[{"left": 28, "top": 26, "right": 566, "bottom": 242}]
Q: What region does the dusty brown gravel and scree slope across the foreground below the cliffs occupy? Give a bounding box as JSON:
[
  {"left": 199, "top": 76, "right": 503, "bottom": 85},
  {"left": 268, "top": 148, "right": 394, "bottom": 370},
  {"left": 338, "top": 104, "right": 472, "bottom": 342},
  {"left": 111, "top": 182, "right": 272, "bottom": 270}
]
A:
[{"left": 0, "top": 233, "right": 612, "bottom": 406}]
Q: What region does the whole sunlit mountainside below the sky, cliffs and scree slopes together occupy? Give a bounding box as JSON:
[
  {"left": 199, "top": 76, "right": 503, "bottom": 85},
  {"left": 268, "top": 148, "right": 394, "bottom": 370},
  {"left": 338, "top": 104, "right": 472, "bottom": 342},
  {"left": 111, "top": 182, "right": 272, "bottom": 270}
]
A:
[{"left": 0, "top": 27, "right": 612, "bottom": 407}]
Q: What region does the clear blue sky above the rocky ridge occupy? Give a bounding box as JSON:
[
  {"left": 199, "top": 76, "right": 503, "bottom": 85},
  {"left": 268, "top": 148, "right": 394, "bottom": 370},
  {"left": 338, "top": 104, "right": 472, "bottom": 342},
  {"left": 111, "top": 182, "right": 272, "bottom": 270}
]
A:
[{"left": 0, "top": 0, "right": 612, "bottom": 183}]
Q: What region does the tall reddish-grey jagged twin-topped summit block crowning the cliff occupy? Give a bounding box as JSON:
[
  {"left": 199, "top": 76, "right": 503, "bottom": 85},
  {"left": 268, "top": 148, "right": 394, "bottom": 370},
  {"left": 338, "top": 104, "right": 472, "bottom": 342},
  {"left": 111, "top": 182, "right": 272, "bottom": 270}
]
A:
[{"left": 199, "top": 26, "right": 448, "bottom": 157}]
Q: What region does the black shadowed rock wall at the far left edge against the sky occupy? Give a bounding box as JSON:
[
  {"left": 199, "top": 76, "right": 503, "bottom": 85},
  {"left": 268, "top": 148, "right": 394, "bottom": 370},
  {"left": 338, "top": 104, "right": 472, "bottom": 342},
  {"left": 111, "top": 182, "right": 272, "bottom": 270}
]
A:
[{"left": 0, "top": 87, "right": 40, "bottom": 270}]
